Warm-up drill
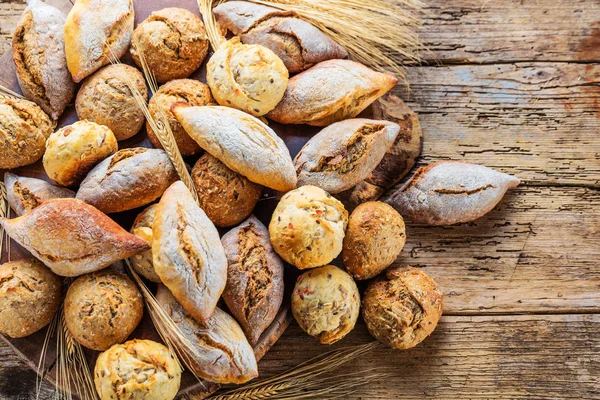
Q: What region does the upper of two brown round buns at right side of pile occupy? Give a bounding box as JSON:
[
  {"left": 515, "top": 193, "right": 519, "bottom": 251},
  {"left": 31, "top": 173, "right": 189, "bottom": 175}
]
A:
[{"left": 342, "top": 201, "right": 406, "bottom": 279}]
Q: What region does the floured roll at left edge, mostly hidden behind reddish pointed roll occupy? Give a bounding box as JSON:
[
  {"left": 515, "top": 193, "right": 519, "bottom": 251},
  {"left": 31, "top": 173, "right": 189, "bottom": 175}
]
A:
[{"left": 4, "top": 172, "right": 75, "bottom": 216}]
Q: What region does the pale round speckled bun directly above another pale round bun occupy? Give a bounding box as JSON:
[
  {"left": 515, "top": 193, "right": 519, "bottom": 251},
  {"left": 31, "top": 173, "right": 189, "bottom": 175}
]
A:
[{"left": 269, "top": 186, "right": 348, "bottom": 269}]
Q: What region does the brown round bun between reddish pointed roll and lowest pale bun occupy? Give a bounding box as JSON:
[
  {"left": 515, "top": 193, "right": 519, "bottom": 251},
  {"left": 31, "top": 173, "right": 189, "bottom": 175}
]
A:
[{"left": 64, "top": 270, "right": 144, "bottom": 350}]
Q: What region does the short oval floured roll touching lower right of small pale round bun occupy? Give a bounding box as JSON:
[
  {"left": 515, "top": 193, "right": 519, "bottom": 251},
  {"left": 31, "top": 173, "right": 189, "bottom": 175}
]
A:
[{"left": 77, "top": 147, "right": 178, "bottom": 214}]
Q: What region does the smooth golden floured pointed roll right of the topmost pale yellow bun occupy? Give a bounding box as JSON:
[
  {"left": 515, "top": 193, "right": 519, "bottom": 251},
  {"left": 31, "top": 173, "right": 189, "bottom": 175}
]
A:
[{"left": 267, "top": 60, "right": 398, "bottom": 126}]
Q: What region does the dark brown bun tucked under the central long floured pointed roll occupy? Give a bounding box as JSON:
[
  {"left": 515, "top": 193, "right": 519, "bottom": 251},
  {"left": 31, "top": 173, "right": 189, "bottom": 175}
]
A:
[{"left": 192, "top": 153, "right": 262, "bottom": 227}]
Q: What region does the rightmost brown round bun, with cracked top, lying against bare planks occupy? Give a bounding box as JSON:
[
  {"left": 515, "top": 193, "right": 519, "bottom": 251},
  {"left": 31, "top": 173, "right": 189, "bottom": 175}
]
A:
[{"left": 362, "top": 266, "right": 442, "bottom": 349}]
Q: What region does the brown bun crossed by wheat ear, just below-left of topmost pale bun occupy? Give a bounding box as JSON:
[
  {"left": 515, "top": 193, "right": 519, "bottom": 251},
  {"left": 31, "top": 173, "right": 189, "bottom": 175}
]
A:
[{"left": 146, "top": 79, "right": 215, "bottom": 156}]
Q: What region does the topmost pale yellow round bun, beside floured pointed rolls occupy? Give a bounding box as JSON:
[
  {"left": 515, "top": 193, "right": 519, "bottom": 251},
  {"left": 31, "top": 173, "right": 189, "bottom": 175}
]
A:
[{"left": 206, "top": 37, "right": 288, "bottom": 117}]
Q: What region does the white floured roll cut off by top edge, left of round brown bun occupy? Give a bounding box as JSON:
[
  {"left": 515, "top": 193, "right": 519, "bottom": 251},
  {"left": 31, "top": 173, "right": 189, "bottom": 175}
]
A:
[{"left": 64, "top": 0, "right": 134, "bottom": 82}]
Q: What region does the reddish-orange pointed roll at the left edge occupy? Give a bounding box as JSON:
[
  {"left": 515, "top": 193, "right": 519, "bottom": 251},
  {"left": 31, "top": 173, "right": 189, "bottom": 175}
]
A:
[{"left": 0, "top": 199, "right": 150, "bottom": 276}]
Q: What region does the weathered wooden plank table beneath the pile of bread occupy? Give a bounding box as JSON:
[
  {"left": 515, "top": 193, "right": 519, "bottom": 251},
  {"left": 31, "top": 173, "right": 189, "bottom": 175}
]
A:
[{"left": 0, "top": 0, "right": 600, "bottom": 399}]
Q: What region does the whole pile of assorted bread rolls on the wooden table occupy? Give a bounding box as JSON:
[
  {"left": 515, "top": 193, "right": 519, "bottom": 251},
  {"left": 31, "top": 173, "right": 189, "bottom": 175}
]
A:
[{"left": 0, "top": 0, "right": 519, "bottom": 400}]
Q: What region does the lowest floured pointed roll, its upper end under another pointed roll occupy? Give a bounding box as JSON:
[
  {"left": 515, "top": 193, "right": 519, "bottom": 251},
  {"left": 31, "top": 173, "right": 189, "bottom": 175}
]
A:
[{"left": 156, "top": 285, "right": 258, "bottom": 384}]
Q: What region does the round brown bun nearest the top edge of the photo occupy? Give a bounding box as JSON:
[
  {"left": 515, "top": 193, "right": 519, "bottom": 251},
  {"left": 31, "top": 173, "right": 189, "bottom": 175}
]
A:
[{"left": 131, "top": 7, "right": 208, "bottom": 83}]
